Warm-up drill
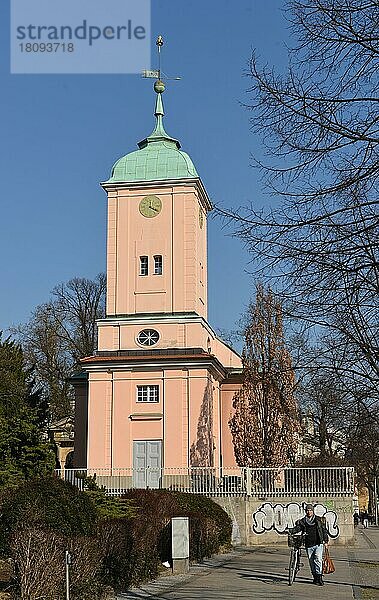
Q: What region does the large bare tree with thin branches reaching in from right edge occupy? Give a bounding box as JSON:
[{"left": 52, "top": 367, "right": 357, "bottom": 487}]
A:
[{"left": 219, "top": 0, "right": 379, "bottom": 422}]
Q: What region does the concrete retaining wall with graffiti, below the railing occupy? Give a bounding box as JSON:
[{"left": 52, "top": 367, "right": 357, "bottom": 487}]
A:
[{"left": 213, "top": 496, "right": 354, "bottom": 546}]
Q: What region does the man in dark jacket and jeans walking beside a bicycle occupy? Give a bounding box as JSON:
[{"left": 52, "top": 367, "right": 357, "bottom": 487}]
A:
[{"left": 290, "top": 504, "right": 329, "bottom": 585}]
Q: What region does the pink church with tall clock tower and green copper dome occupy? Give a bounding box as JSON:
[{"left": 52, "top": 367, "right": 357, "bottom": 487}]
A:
[{"left": 74, "top": 82, "right": 241, "bottom": 485}]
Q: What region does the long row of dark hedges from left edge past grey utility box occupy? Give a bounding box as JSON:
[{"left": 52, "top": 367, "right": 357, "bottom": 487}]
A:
[{"left": 0, "top": 477, "right": 231, "bottom": 600}]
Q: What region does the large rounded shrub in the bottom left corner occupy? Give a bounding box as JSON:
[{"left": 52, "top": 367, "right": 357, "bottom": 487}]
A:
[{"left": 0, "top": 477, "right": 108, "bottom": 600}]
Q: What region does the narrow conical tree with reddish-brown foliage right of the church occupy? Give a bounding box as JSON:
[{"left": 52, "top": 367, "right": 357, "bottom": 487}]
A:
[{"left": 229, "top": 284, "right": 300, "bottom": 467}]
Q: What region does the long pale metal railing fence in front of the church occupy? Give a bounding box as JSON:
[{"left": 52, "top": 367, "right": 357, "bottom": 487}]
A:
[{"left": 55, "top": 467, "right": 354, "bottom": 498}]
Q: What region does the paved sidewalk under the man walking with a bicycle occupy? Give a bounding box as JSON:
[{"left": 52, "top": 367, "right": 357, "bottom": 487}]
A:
[{"left": 118, "top": 526, "right": 379, "bottom": 600}]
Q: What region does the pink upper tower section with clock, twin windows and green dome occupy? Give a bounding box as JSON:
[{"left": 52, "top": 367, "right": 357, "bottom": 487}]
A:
[{"left": 102, "top": 82, "right": 211, "bottom": 322}]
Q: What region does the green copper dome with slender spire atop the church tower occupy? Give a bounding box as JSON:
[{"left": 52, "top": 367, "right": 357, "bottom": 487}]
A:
[{"left": 107, "top": 82, "right": 199, "bottom": 183}]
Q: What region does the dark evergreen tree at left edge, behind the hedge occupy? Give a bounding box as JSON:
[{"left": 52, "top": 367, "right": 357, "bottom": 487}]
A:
[{"left": 0, "top": 335, "right": 55, "bottom": 488}]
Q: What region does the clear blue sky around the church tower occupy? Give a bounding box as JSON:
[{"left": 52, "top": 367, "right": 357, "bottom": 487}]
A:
[{"left": 0, "top": 0, "right": 288, "bottom": 342}]
